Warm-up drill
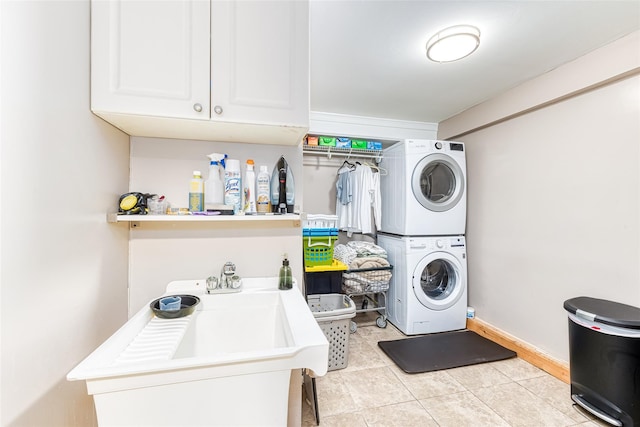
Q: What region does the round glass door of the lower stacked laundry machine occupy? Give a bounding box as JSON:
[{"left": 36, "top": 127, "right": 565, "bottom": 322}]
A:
[{"left": 412, "top": 252, "right": 467, "bottom": 310}]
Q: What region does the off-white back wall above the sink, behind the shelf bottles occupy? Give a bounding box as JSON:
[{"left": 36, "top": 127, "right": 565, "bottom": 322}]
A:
[{"left": 129, "top": 137, "right": 303, "bottom": 314}]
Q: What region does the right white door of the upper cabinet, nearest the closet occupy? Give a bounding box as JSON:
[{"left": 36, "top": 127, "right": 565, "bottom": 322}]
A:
[{"left": 211, "top": 0, "right": 309, "bottom": 127}]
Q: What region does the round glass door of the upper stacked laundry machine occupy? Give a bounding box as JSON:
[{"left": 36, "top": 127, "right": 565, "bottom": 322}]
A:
[{"left": 411, "top": 153, "right": 464, "bottom": 212}]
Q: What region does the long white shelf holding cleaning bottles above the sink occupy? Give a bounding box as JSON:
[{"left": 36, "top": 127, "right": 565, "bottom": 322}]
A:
[{"left": 107, "top": 213, "right": 301, "bottom": 227}]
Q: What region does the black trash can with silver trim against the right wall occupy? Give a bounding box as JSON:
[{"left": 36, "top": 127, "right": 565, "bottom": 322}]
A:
[{"left": 564, "top": 297, "right": 640, "bottom": 427}]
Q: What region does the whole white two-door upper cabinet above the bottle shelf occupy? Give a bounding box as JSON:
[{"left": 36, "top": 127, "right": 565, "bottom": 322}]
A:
[{"left": 91, "top": 0, "right": 309, "bottom": 145}]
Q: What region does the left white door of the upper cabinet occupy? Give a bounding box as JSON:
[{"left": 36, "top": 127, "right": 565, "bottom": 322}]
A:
[{"left": 91, "top": 0, "right": 210, "bottom": 120}]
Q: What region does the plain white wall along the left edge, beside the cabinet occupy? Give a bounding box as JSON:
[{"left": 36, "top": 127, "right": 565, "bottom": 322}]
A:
[{"left": 0, "top": 0, "right": 129, "bottom": 426}]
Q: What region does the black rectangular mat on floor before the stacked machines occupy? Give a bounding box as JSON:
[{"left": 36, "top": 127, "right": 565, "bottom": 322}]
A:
[{"left": 378, "top": 330, "right": 516, "bottom": 374}]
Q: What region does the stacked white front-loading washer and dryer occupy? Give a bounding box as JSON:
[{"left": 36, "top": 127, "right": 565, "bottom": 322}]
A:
[{"left": 378, "top": 140, "right": 467, "bottom": 335}]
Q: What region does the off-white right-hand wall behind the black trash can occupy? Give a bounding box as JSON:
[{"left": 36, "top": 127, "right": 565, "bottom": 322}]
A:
[{"left": 440, "top": 34, "right": 640, "bottom": 362}]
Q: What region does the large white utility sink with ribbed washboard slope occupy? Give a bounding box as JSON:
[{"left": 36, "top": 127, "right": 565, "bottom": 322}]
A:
[{"left": 67, "top": 277, "right": 329, "bottom": 426}]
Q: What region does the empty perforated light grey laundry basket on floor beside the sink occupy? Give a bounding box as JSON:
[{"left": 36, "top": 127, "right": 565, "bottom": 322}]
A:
[{"left": 307, "top": 294, "right": 356, "bottom": 371}]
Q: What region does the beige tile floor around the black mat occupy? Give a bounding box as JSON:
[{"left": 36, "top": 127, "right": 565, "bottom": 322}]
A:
[{"left": 302, "top": 313, "right": 607, "bottom": 427}]
